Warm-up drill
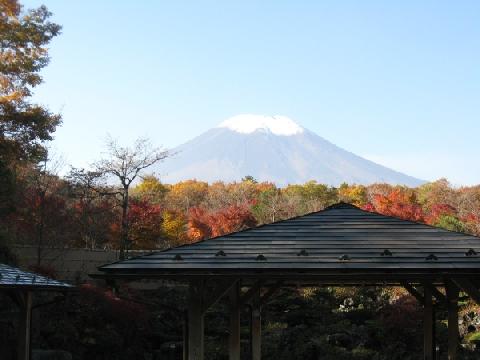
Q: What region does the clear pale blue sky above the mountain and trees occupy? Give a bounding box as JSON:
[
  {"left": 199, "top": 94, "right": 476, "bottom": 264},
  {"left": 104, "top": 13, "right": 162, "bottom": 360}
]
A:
[{"left": 22, "top": 0, "right": 480, "bottom": 185}]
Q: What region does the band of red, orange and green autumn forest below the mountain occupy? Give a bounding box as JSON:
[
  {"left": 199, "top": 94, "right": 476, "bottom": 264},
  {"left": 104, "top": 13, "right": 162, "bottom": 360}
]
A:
[{"left": 1, "top": 158, "right": 480, "bottom": 261}]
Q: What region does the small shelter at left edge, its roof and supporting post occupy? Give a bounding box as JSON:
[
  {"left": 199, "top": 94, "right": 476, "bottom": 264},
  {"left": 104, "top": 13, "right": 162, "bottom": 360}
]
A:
[{"left": 0, "top": 264, "right": 72, "bottom": 360}]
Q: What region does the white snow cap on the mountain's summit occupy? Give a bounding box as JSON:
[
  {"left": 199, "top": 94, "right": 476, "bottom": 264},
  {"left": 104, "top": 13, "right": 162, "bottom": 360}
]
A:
[{"left": 218, "top": 114, "right": 304, "bottom": 136}]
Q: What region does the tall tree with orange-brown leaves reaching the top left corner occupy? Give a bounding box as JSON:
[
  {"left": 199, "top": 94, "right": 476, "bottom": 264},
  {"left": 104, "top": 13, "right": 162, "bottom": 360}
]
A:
[{"left": 0, "top": 0, "right": 61, "bottom": 212}]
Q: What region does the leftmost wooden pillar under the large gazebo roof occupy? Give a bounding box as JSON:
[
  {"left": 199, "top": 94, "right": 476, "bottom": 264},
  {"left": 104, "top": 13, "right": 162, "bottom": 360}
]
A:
[{"left": 187, "top": 280, "right": 205, "bottom": 360}]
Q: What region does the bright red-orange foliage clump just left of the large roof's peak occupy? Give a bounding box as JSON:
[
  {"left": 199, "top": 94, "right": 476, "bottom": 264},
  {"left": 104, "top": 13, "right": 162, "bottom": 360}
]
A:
[{"left": 188, "top": 204, "right": 257, "bottom": 241}]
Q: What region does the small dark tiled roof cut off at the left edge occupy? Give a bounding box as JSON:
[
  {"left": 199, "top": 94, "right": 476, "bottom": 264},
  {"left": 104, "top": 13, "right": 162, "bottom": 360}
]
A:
[{"left": 0, "top": 264, "right": 71, "bottom": 290}]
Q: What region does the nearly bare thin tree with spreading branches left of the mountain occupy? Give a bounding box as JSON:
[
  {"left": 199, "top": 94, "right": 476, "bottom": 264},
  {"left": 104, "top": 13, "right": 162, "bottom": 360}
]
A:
[{"left": 95, "top": 137, "right": 169, "bottom": 259}]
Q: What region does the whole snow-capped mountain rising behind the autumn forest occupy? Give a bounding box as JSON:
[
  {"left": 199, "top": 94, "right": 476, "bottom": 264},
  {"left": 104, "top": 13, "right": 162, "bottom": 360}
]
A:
[{"left": 154, "top": 115, "right": 423, "bottom": 186}]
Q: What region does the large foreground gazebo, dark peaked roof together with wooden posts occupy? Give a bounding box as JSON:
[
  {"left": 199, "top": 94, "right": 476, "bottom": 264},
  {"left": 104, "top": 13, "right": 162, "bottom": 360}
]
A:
[{"left": 99, "top": 203, "right": 480, "bottom": 360}]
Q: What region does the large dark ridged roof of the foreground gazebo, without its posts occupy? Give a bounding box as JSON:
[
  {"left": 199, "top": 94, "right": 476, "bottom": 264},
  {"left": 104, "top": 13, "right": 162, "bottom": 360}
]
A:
[{"left": 99, "top": 203, "right": 480, "bottom": 280}]
